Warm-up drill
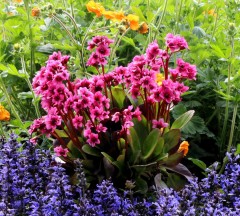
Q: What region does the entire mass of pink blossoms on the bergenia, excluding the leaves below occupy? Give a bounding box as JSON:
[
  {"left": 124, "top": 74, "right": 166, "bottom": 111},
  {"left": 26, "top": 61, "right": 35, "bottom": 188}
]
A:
[{"left": 29, "top": 34, "right": 197, "bottom": 157}]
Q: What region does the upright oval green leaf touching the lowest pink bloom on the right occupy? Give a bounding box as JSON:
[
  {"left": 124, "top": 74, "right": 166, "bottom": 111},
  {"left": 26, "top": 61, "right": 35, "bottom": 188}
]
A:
[{"left": 142, "top": 128, "right": 161, "bottom": 160}]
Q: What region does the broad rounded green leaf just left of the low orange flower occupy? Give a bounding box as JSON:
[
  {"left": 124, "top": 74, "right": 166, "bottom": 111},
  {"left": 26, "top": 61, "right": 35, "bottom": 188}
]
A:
[{"left": 163, "top": 129, "right": 181, "bottom": 152}]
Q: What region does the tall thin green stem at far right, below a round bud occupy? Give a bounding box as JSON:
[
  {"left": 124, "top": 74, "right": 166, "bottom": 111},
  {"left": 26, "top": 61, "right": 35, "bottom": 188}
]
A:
[{"left": 220, "top": 36, "right": 234, "bottom": 153}]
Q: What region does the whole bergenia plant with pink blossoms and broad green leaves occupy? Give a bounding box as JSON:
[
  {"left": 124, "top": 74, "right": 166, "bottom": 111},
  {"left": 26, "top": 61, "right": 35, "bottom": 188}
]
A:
[{"left": 30, "top": 34, "right": 197, "bottom": 192}]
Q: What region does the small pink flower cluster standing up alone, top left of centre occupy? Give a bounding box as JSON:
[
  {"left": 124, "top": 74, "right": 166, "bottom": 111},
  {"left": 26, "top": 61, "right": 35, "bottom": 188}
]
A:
[{"left": 87, "top": 36, "right": 113, "bottom": 66}]
